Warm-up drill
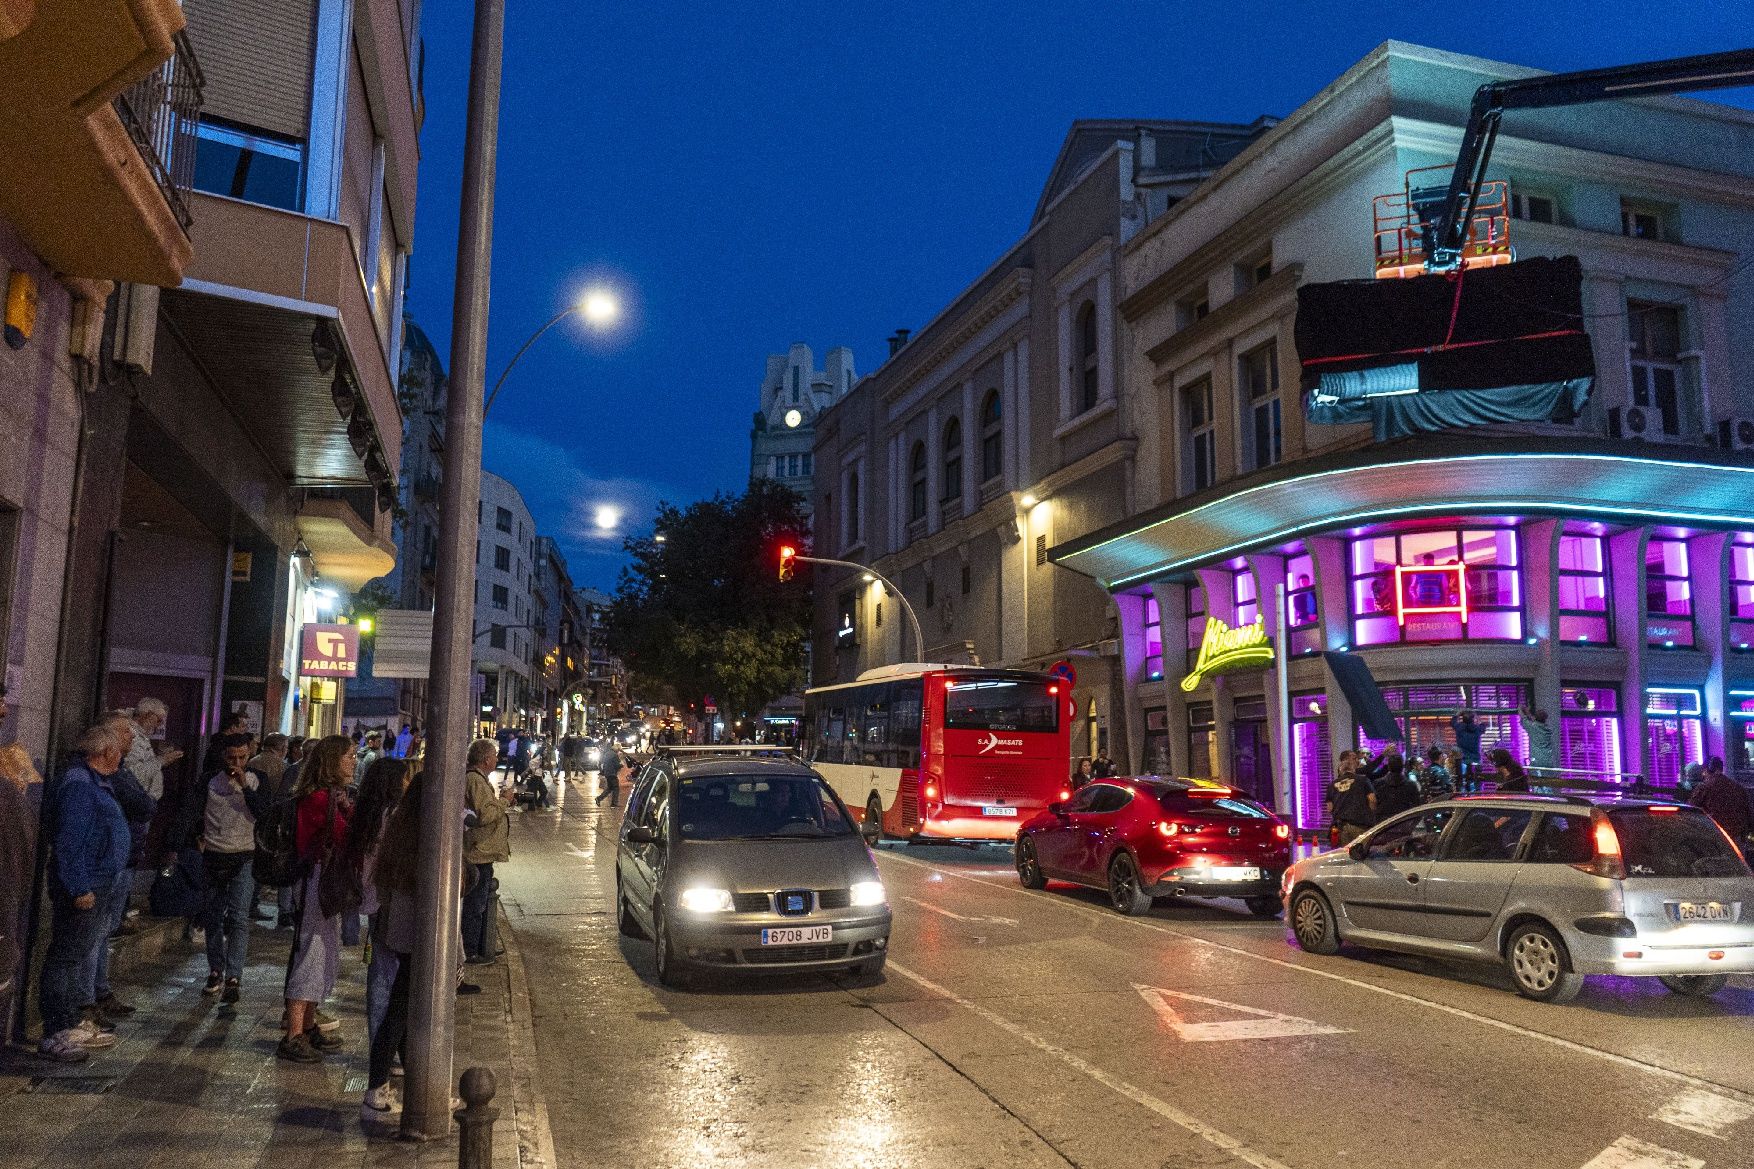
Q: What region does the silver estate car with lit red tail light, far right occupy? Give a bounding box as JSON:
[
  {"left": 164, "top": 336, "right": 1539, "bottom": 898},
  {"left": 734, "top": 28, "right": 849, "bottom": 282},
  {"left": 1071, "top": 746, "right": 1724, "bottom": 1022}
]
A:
[{"left": 1284, "top": 795, "right": 1754, "bottom": 1002}]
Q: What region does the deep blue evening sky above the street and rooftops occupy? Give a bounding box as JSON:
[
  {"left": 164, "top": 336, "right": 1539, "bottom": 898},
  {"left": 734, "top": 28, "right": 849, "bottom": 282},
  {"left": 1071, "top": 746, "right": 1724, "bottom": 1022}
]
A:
[{"left": 409, "top": 0, "right": 1754, "bottom": 588}]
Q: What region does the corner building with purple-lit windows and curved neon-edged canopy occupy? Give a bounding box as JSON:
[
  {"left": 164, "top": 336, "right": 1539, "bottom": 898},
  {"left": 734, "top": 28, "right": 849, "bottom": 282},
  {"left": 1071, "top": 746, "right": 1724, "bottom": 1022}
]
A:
[{"left": 1047, "top": 42, "right": 1754, "bottom": 827}]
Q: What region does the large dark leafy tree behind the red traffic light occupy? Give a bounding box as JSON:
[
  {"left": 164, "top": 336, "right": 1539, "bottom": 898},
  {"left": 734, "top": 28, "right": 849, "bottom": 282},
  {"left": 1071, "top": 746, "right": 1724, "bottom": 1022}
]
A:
[{"left": 609, "top": 479, "right": 810, "bottom": 714}]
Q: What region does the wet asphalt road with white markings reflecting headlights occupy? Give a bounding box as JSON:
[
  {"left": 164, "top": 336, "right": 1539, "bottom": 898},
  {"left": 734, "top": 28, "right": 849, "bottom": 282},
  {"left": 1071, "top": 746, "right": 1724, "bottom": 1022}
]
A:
[{"left": 500, "top": 772, "right": 1754, "bottom": 1169}]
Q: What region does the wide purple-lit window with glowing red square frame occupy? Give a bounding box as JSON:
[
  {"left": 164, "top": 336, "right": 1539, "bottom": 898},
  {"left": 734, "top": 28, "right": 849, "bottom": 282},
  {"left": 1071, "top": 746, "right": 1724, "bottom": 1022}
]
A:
[{"left": 1351, "top": 528, "right": 1522, "bottom": 646}]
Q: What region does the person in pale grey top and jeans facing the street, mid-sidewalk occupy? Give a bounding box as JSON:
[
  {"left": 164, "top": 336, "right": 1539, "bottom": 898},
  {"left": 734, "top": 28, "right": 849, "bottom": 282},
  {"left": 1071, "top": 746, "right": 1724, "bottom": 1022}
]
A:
[{"left": 179, "top": 734, "right": 270, "bottom": 1006}]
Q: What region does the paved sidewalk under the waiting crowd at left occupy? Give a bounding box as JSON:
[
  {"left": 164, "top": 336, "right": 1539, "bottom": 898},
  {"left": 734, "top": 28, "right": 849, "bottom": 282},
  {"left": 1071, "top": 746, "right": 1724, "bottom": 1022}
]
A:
[{"left": 0, "top": 898, "right": 554, "bottom": 1169}]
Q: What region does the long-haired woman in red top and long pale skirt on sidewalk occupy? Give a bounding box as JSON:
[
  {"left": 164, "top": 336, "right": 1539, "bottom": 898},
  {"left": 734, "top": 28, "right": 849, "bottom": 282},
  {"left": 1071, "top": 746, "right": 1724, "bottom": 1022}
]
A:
[{"left": 277, "top": 735, "right": 358, "bottom": 1064}]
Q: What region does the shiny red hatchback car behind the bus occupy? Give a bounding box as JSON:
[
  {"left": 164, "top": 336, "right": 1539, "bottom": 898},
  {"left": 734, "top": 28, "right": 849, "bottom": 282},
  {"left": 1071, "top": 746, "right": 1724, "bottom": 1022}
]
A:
[{"left": 1016, "top": 776, "right": 1291, "bottom": 918}]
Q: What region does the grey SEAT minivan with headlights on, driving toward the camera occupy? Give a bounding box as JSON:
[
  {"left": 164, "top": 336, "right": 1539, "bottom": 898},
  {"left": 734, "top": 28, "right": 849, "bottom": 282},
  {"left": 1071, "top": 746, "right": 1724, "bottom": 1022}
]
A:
[{"left": 616, "top": 755, "right": 891, "bottom": 986}]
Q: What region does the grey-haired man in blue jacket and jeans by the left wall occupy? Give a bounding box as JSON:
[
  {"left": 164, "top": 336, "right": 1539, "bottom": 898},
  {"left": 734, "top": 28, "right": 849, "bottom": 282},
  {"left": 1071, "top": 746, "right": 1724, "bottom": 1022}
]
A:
[{"left": 39, "top": 723, "right": 130, "bottom": 1062}]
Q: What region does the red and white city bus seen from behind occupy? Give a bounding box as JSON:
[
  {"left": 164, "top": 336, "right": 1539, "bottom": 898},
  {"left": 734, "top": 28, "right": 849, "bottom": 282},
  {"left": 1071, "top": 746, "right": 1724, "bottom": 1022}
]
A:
[{"left": 800, "top": 663, "right": 1072, "bottom": 841}]
